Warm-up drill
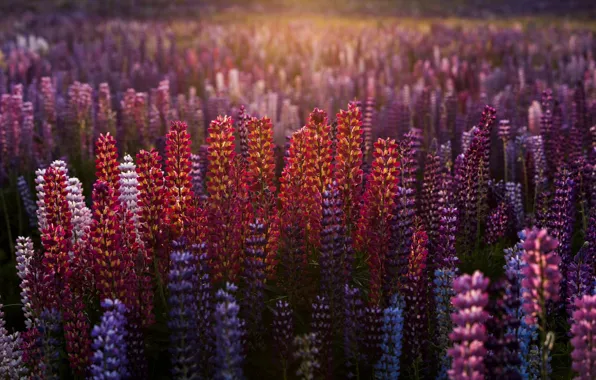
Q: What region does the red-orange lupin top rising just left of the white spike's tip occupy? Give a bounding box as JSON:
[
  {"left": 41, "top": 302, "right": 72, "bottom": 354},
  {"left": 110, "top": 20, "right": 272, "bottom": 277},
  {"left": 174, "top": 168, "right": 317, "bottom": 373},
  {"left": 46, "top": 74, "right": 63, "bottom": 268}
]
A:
[{"left": 95, "top": 133, "right": 120, "bottom": 197}]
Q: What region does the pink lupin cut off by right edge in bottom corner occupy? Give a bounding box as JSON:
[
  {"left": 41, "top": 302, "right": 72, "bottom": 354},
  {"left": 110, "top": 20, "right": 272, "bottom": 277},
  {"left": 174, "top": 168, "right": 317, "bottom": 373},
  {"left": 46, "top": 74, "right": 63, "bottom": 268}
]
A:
[{"left": 571, "top": 295, "right": 596, "bottom": 380}]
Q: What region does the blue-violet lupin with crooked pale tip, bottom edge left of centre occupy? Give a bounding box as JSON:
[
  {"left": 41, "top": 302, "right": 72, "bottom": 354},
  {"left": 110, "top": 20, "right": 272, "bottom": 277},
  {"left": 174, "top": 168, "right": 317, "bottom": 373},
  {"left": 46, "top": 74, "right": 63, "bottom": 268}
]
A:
[{"left": 214, "top": 283, "right": 244, "bottom": 380}]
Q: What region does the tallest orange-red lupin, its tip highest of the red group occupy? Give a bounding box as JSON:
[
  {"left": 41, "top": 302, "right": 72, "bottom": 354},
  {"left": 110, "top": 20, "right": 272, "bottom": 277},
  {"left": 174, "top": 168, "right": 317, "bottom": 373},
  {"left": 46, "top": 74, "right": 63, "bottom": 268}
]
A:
[{"left": 334, "top": 103, "right": 363, "bottom": 235}]
